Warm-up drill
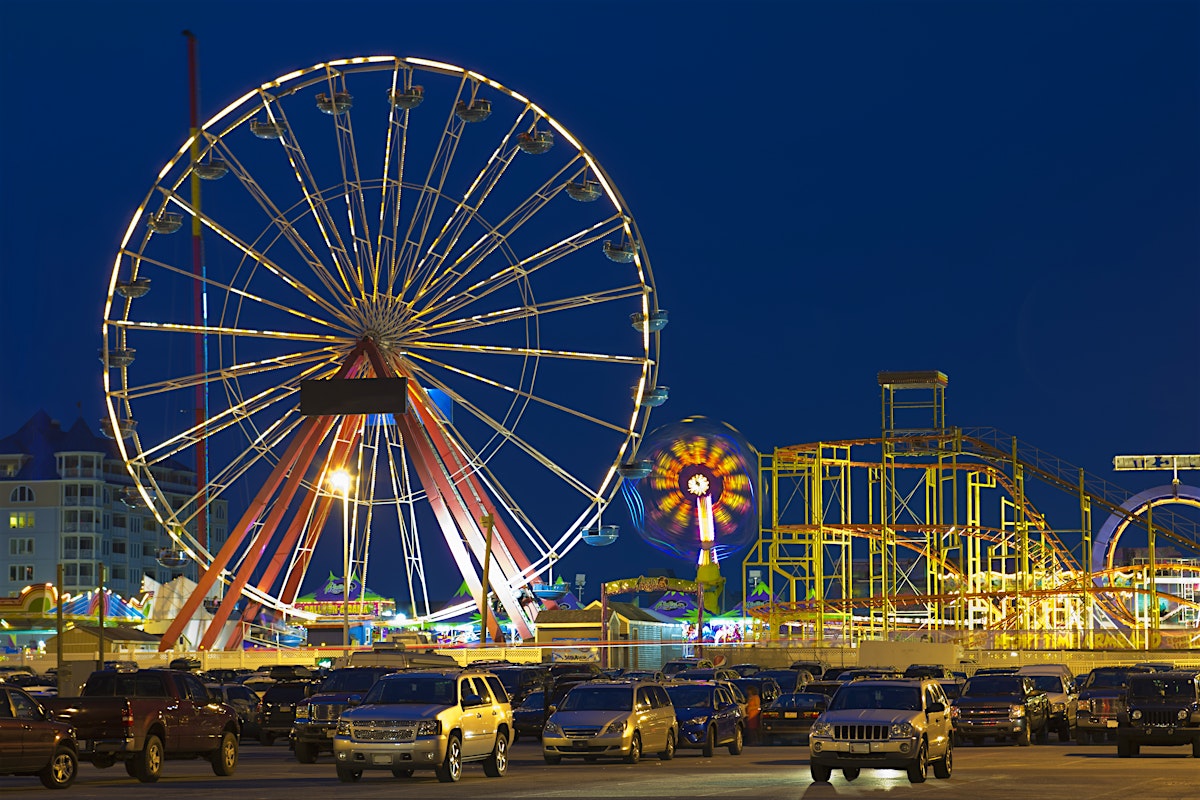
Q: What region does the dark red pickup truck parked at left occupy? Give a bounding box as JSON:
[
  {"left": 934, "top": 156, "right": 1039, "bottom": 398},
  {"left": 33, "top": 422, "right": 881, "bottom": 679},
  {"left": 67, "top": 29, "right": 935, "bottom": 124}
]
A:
[{"left": 46, "top": 669, "right": 239, "bottom": 783}]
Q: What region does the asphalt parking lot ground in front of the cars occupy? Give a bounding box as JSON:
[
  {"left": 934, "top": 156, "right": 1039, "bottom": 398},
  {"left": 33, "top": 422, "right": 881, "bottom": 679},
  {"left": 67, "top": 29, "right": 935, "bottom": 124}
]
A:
[{"left": 0, "top": 740, "right": 1200, "bottom": 800}]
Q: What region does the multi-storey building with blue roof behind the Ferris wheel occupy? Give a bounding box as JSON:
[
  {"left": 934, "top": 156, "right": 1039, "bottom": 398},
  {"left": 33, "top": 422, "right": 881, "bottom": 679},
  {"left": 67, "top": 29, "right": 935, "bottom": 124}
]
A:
[{"left": 0, "top": 411, "right": 228, "bottom": 597}]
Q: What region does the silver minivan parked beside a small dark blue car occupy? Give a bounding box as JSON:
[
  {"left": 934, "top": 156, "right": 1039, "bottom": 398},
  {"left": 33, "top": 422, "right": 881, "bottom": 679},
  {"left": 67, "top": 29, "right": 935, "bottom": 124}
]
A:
[{"left": 541, "top": 680, "right": 679, "bottom": 764}]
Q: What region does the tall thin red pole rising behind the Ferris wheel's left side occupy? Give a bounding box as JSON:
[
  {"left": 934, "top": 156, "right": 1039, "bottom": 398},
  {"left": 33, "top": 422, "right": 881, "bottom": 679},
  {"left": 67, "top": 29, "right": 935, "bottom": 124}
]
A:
[{"left": 184, "top": 30, "right": 209, "bottom": 575}]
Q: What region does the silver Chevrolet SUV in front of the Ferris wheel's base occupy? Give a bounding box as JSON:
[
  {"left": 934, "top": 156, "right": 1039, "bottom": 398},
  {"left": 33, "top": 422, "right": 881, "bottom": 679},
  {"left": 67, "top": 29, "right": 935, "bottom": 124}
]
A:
[{"left": 334, "top": 668, "right": 512, "bottom": 783}]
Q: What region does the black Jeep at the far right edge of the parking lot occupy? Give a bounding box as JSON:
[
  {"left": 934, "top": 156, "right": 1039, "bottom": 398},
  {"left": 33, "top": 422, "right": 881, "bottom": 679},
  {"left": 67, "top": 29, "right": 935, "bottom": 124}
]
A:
[{"left": 1117, "top": 669, "right": 1200, "bottom": 758}]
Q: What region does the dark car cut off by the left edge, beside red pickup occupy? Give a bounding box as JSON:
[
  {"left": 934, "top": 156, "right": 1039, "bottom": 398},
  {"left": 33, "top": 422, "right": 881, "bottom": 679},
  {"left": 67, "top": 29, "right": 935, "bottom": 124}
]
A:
[{"left": 0, "top": 685, "right": 79, "bottom": 789}]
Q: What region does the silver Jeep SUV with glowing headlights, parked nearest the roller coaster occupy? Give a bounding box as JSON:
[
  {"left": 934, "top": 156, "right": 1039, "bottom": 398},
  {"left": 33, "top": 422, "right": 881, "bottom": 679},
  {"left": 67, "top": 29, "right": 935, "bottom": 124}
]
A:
[{"left": 809, "top": 678, "right": 954, "bottom": 783}]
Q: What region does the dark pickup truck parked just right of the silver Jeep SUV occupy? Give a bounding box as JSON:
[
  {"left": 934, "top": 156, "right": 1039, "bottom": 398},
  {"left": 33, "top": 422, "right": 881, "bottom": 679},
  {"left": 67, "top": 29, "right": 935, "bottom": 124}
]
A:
[{"left": 950, "top": 675, "right": 1050, "bottom": 747}]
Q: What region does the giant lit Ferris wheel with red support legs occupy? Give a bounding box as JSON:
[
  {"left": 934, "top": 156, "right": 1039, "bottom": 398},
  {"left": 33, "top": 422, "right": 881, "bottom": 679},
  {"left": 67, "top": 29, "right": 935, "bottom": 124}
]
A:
[{"left": 102, "top": 56, "right": 666, "bottom": 648}]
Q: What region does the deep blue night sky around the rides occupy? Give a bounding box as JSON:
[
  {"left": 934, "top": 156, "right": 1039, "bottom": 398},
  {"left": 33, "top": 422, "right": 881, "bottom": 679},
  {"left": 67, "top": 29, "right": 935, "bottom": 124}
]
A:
[{"left": 0, "top": 0, "right": 1200, "bottom": 594}]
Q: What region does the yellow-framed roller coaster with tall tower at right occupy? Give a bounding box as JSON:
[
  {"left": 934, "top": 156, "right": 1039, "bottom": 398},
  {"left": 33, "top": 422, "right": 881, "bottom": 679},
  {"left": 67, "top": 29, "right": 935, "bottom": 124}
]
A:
[{"left": 743, "top": 372, "right": 1200, "bottom": 650}]
